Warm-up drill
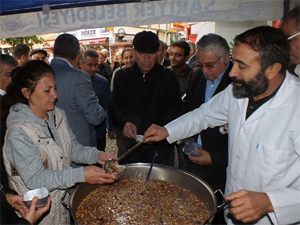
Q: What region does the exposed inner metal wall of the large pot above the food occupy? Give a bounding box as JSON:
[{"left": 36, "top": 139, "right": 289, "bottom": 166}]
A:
[{"left": 65, "top": 163, "right": 217, "bottom": 224}]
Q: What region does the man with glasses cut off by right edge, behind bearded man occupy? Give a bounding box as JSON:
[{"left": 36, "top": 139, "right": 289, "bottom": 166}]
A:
[{"left": 280, "top": 6, "right": 300, "bottom": 78}]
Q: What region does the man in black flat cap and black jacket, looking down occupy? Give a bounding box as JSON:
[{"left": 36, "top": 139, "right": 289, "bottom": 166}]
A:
[{"left": 109, "top": 31, "right": 181, "bottom": 165}]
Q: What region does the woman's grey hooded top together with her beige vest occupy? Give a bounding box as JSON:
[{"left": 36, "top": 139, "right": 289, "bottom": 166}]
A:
[{"left": 3, "top": 104, "right": 99, "bottom": 224}]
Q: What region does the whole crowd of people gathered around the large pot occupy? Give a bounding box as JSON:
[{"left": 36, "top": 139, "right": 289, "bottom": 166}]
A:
[{"left": 0, "top": 6, "right": 300, "bottom": 224}]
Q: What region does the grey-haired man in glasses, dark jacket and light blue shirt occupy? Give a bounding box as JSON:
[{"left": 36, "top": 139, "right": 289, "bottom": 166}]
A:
[{"left": 185, "top": 34, "right": 232, "bottom": 224}]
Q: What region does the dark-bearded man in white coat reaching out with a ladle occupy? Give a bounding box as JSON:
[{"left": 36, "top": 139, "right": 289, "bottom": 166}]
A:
[{"left": 144, "top": 26, "right": 300, "bottom": 225}]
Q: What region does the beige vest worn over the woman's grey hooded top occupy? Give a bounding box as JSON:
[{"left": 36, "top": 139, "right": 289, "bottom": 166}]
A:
[{"left": 4, "top": 109, "right": 71, "bottom": 225}]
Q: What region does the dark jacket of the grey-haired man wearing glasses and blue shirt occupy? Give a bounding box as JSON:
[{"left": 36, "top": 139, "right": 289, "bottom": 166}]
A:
[{"left": 185, "top": 62, "right": 232, "bottom": 191}]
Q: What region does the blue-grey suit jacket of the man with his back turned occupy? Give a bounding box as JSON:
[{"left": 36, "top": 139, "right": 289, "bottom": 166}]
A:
[{"left": 50, "top": 58, "right": 105, "bottom": 147}]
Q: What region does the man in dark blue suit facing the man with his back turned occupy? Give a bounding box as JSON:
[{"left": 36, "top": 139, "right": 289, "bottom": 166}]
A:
[{"left": 80, "top": 49, "right": 115, "bottom": 151}]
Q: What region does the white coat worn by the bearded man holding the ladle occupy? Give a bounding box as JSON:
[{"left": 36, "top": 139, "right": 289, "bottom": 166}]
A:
[{"left": 165, "top": 73, "right": 300, "bottom": 224}]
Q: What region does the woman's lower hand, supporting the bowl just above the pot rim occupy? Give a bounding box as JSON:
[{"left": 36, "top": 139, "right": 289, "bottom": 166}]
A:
[{"left": 83, "top": 166, "right": 115, "bottom": 184}]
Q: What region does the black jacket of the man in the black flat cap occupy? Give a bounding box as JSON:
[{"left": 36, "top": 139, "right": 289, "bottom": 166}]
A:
[{"left": 109, "top": 63, "right": 181, "bottom": 164}]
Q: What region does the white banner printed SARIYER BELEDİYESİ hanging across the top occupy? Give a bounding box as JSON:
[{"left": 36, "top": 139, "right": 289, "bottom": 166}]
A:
[{"left": 0, "top": 0, "right": 283, "bottom": 39}]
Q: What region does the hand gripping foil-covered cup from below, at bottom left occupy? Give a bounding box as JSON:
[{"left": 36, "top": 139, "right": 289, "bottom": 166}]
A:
[{"left": 21, "top": 196, "right": 51, "bottom": 224}]
